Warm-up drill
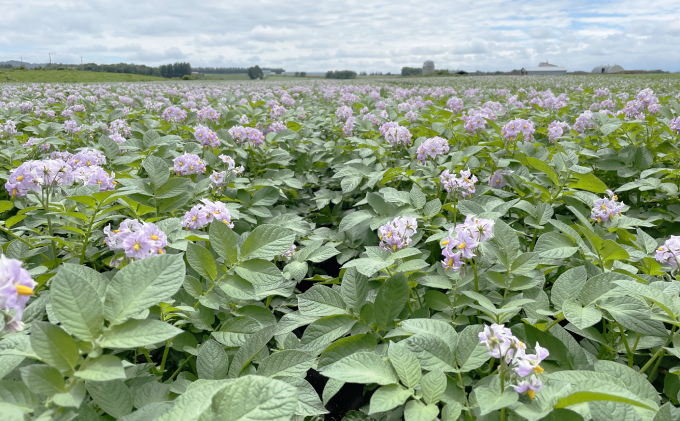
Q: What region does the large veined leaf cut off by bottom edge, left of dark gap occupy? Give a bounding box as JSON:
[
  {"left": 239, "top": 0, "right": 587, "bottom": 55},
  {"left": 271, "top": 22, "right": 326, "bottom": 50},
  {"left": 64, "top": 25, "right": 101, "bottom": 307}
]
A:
[{"left": 201, "top": 376, "right": 298, "bottom": 421}]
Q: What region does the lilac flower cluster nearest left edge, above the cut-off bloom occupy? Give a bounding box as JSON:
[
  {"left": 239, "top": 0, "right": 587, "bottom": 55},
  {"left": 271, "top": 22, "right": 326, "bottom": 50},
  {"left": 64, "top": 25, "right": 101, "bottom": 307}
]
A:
[{"left": 5, "top": 159, "right": 74, "bottom": 198}]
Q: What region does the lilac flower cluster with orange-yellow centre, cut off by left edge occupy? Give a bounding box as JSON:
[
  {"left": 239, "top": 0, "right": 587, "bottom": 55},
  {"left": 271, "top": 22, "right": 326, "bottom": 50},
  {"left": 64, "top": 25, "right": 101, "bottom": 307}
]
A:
[{"left": 0, "top": 254, "right": 37, "bottom": 332}]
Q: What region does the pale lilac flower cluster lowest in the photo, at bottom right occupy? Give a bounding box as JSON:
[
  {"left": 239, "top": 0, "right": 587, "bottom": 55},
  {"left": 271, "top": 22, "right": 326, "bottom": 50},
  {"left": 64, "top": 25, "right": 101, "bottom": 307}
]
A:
[{"left": 479, "top": 323, "right": 550, "bottom": 399}]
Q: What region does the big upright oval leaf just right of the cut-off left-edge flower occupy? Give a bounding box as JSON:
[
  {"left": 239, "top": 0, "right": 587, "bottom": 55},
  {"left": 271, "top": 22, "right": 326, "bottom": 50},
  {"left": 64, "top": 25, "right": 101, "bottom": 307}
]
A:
[{"left": 49, "top": 264, "right": 106, "bottom": 341}]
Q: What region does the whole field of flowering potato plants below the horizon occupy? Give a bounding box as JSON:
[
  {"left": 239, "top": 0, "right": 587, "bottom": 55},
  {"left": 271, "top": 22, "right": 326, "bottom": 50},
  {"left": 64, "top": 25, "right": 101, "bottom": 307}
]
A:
[{"left": 0, "top": 76, "right": 680, "bottom": 421}]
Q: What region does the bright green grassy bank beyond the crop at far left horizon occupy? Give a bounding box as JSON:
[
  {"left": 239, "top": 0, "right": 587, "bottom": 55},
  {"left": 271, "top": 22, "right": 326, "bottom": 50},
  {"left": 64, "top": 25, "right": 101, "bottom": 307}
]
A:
[{"left": 0, "top": 70, "right": 168, "bottom": 83}]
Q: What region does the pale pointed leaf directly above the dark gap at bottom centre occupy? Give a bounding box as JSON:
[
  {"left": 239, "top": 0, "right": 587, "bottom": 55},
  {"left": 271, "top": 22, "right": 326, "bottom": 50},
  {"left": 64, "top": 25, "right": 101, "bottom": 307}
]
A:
[{"left": 321, "top": 351, "right": 399, "bottom": 385}]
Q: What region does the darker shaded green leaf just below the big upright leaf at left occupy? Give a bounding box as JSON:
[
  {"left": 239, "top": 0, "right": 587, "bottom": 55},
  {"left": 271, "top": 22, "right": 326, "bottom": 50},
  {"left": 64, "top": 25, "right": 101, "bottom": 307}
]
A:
[{"left": 31, "top": 321, "right": 80, "bottom": 372}]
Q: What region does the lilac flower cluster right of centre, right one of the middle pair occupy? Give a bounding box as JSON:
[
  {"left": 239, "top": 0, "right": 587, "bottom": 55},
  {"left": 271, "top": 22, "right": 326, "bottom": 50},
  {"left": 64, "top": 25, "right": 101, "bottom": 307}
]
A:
[{"left": 440, "top": 215, "right": 494, "bottom": 272}]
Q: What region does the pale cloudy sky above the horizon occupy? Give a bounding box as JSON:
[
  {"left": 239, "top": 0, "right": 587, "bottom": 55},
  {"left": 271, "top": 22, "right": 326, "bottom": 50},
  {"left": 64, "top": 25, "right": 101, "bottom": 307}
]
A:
[{"left": 0, "top": 0, "right": 680, "bottom": 72}]
